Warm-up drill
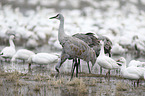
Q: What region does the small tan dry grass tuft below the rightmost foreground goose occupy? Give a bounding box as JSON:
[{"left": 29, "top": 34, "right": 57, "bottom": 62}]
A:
[{"left": 116, "top": 82, "right": 129, "bottom": 91}]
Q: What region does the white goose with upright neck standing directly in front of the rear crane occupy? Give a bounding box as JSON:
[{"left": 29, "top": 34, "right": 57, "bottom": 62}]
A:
[{"left": 97, "top": 41, "right": 120, "bottom": 77}]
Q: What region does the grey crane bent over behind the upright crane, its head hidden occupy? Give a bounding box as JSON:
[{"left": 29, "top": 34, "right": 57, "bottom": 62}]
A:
[{"left": 73, "top": 33, "right": 112, "bottom": 73}]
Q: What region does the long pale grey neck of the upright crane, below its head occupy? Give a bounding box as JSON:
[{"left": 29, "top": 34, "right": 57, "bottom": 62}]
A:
[{"left": 58, "top": 17, "right": 67, "bottom": 42}]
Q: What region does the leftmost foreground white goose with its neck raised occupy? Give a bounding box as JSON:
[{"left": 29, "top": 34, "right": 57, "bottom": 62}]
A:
[{"left": 0, "top": 35, "right": 16, "bottom": 59}]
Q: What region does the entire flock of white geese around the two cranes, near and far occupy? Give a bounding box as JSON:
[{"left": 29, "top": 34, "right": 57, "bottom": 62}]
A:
[{"left": 0, "top": 1, "right": 145, "bottom": 86}]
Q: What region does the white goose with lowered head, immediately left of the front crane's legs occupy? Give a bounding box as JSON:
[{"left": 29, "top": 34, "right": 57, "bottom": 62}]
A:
[{"left": 28, "top": 53, "right": 59, "bottom": 67}]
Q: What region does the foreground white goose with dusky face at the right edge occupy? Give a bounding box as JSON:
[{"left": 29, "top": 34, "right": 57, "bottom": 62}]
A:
[{"left": 118, "top": 57, "right": 145, "bottom": 85}]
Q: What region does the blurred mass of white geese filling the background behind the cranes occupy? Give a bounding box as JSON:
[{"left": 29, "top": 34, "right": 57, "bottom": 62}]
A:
[{"left": 0, "top": 0, "right": 145, "bottom": 51}]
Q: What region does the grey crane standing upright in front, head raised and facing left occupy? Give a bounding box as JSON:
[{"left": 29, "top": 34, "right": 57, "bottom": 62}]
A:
[{"left": 50, "top": 14, "right": 96, "bottom": 78}]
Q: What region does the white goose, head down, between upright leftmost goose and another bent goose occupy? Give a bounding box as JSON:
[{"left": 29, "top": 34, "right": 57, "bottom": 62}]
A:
[{"left": 11, "top": 49, "right": 35, "bottom": 62}]
